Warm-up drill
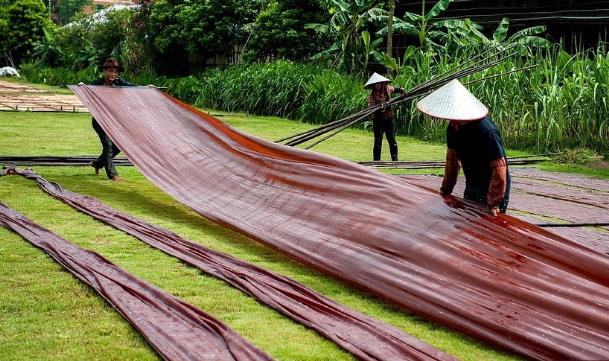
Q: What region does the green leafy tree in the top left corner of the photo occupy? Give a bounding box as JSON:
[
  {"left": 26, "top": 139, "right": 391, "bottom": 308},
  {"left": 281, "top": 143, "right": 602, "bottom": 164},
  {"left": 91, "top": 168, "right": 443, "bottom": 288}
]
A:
[{"left": 0, "top": 0, "right": 51, "bottom": 64}]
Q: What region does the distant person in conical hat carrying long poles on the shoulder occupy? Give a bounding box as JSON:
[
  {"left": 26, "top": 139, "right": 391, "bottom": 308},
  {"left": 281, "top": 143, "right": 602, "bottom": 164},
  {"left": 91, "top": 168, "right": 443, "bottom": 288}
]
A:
[{"left": 364, "top": 73, "right": 404, "bottom": 161}]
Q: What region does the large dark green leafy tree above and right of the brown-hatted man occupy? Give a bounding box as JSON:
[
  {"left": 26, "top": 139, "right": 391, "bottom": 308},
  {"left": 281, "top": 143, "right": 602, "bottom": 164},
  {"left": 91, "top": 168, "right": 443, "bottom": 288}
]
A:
[{"left": 136, "top": 0, "right": 259, "bottom": 74}]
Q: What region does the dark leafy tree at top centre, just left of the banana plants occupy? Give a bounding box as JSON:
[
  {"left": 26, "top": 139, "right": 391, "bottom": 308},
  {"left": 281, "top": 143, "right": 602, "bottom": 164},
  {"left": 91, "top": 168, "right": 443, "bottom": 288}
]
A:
[{"left": 246, "top": 0, "right": 328, "bottom": 61}]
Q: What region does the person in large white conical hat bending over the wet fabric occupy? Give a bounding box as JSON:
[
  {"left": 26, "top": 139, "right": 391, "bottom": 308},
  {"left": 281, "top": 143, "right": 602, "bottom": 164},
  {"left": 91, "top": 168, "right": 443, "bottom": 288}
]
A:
[{"left": 417, "top": 79, "right": 510, "bottom": 216}]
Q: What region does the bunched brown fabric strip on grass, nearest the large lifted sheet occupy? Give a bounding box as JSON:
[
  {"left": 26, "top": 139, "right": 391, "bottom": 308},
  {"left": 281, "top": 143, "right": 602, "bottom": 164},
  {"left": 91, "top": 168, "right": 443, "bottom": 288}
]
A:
[{"left": 4, "top": 169, "right": 454, "bottom": 361}]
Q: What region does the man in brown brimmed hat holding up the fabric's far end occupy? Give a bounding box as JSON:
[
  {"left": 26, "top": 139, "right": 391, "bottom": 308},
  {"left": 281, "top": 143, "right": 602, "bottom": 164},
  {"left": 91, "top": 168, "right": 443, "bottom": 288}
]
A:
[{"left": 91, "top": 58, "right": 135, "bottom": 181}]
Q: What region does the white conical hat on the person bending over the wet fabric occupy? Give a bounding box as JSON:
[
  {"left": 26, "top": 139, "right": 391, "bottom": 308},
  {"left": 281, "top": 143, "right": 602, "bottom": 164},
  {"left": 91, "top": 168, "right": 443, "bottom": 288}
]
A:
[{"left": 417, "top": 79, "right": 488, "bottom": 121}]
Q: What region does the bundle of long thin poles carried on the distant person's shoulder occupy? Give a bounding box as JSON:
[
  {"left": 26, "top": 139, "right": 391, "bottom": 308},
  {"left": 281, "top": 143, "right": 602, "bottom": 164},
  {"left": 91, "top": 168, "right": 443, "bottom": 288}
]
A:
[{"left": 275, "top": 44, "right": 531, "bottom": 149}]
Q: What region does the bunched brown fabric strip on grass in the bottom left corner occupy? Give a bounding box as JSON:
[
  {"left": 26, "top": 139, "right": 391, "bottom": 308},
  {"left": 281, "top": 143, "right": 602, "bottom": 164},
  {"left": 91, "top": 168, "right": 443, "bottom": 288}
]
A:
[{"left": 0, "top": 203, "right": 272, "bottom": 361}]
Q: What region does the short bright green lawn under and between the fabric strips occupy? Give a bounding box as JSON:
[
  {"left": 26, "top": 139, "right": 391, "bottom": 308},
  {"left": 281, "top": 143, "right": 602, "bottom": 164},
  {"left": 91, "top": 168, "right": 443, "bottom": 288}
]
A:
[{"left": 0, "top": 81, "right": 600, "bottom": 360}]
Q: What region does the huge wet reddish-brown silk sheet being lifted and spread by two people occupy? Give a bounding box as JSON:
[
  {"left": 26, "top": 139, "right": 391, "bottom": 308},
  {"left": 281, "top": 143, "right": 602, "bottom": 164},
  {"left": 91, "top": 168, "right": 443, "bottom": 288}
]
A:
[{"left": 72, "top": 86, "right": 609, "bottom": 360}]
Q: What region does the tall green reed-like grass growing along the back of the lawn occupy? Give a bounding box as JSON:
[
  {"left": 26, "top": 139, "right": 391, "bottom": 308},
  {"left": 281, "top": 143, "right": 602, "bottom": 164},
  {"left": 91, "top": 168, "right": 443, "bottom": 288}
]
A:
[{"left": 22, "top": 47, "right": 609, "bottom": 154}]
